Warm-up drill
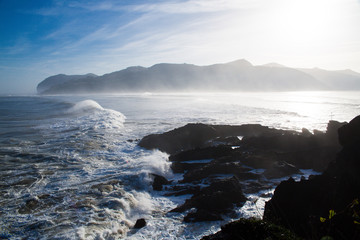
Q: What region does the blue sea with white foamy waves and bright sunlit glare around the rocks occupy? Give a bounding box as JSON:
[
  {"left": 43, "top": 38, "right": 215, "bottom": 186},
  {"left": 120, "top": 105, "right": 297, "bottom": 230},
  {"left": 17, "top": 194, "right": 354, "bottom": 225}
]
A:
[{"left": 0, "top": 92, "right": 360, "bottom": 239}]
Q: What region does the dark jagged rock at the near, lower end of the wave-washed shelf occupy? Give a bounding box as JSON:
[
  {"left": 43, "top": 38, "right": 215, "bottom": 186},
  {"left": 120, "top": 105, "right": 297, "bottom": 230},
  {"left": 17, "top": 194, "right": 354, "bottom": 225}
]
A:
[{"left": 171, "top": 177, "right": 246, "bottom": 222}]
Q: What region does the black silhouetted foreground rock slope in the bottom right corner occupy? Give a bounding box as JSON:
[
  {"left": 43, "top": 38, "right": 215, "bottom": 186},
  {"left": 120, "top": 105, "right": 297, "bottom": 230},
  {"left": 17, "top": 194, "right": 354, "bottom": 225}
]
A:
[{"left": 264, "top": 116, "right": 360, "bottom": 239}]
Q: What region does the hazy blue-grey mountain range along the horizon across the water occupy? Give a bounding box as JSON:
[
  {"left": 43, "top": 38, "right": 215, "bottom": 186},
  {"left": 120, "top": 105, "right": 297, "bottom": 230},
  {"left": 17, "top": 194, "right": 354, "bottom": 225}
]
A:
[{"left": 37, "top": 59, "right": 360, "bottom": 94}]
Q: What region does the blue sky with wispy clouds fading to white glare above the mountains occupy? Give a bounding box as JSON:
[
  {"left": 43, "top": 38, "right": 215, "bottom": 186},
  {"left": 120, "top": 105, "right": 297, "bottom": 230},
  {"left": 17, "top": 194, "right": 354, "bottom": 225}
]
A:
[{"left": 0, "top": 0, "right": 360, "bottom": 94}]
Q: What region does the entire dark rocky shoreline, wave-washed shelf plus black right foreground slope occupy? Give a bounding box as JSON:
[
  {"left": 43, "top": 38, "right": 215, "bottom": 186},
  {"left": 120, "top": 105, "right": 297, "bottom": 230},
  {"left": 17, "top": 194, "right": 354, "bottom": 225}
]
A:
[{"left": 138, "top": 117, "right": 360, "bottom": 239}]
